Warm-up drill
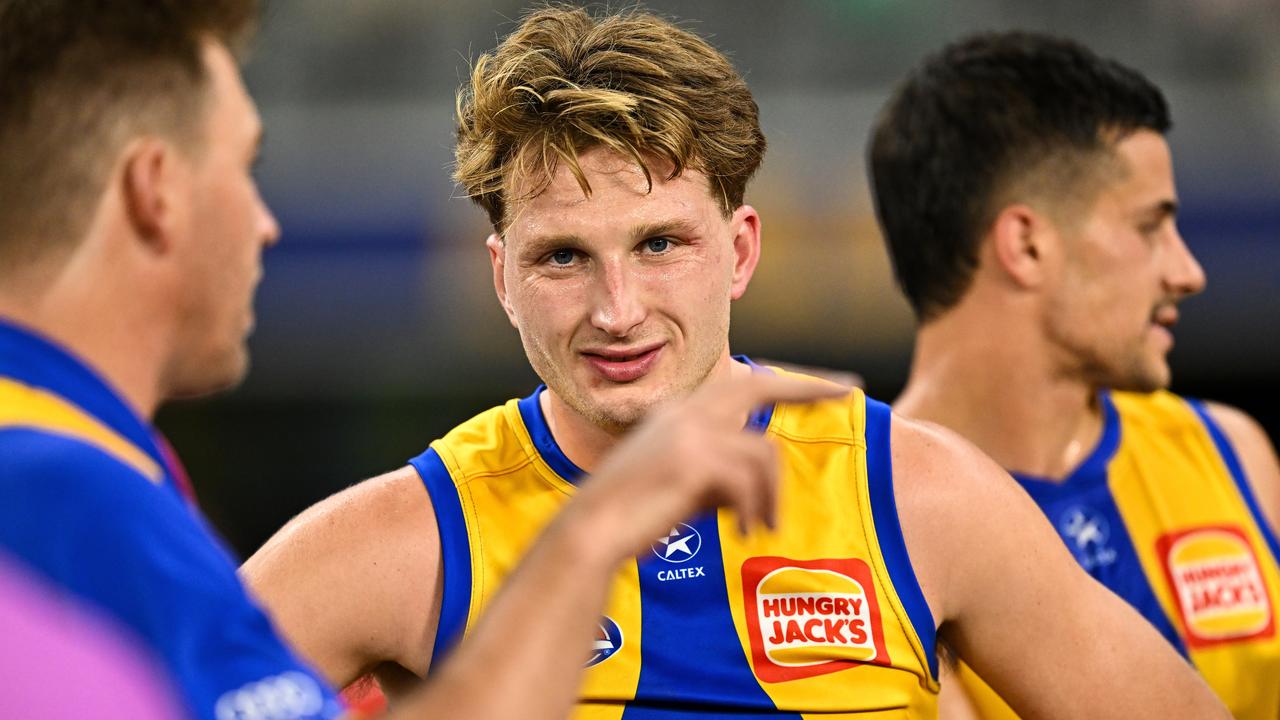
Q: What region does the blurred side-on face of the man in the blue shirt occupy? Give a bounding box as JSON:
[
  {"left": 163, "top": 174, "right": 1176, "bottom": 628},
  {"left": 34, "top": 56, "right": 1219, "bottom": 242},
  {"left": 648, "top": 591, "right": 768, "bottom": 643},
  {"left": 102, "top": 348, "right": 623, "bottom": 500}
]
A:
[{"left": 168, "top": 44, "right": 279, "bottom": 396}]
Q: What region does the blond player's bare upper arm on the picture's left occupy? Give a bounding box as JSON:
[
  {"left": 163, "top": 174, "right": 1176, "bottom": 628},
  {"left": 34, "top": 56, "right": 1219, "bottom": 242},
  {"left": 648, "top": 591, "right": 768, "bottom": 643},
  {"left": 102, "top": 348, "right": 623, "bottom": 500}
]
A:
[{"left": 241, "top": 468, "right": 442, "bottom": 687}]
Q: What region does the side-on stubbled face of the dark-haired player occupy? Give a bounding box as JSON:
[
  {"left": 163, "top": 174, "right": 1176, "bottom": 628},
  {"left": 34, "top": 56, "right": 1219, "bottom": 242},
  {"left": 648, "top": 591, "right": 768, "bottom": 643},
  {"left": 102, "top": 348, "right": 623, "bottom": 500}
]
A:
[{"left": 1047, "top": 131, "right": 1204, "bottom": 392}]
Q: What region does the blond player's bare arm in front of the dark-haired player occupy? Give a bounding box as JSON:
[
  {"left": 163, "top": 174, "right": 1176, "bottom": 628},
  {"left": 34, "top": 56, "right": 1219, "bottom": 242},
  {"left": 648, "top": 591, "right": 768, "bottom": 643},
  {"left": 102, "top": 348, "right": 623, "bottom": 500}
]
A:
[{"left": 892, "top": 416, "right": 1229, "bottom": 720}]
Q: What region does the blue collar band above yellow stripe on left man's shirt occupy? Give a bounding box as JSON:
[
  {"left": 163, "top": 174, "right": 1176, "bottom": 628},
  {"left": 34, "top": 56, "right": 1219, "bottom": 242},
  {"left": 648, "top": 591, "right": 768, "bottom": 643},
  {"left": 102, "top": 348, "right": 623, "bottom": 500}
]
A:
[{"left": 0, "top": 319, "right": 174, "bottom": 476}]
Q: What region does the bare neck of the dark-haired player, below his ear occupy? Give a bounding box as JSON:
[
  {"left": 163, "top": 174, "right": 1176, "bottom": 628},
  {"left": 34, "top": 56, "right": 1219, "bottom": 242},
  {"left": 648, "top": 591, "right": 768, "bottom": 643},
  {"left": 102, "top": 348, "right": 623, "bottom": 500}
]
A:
[{"left": 893, "top": 309, "right": 1102, "bottom": 479}]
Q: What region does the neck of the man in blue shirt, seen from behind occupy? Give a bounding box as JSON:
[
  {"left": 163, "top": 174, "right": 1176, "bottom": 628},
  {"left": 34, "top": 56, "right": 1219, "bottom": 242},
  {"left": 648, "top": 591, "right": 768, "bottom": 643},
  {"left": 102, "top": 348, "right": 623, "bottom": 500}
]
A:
[{"left": 0, "top": 235, "right": 166, "bottom": 420}]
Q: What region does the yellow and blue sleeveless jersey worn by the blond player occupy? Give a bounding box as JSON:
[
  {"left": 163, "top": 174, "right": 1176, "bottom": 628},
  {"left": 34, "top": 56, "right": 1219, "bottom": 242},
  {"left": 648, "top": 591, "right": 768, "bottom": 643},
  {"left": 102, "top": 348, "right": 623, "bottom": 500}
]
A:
[{"left": 411, "top": 361, "right": 937, "bottom": 720}]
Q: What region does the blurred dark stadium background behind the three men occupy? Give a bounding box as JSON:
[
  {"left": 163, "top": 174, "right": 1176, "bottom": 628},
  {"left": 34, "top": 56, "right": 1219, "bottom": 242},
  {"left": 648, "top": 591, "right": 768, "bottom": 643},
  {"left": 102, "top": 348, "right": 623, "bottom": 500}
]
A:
[{"left": 159, "top": 0, "right": 1280, "bottom": 555}]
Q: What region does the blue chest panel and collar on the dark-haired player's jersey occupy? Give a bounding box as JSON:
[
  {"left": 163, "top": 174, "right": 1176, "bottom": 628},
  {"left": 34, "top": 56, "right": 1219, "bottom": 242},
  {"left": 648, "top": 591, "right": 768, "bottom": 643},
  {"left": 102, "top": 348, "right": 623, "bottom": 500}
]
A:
[{"left": 1014, "top": 395, "right": 1188, "bottom": 657}]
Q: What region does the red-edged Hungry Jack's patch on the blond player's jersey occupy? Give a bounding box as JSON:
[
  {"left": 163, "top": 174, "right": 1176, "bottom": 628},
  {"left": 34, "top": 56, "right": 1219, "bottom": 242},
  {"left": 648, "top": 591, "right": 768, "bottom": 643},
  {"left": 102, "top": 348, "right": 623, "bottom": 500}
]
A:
[{"left": 742, "top": 557, "right": 890, "bottom": 683}]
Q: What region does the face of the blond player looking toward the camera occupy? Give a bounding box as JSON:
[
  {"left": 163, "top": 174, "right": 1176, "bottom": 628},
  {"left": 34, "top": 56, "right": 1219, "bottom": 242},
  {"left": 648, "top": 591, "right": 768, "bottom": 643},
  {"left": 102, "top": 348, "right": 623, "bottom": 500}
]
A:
[{"left": 489, "top": 142, "right": 760, "bottom": 432}]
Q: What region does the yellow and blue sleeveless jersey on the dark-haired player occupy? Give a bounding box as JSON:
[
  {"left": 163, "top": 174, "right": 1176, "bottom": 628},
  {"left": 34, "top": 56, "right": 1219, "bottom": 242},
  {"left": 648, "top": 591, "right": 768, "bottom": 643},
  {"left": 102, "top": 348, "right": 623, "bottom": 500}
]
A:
[{"left": 960, "top": 392, "right": 1280, "bottom": 720}]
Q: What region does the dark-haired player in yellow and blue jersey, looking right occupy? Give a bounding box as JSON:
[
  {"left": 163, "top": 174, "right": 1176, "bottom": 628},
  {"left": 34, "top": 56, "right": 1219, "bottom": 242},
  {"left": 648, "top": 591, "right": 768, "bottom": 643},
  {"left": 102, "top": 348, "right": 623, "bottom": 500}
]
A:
[{"left": 869, "top": 33, "right": 1280, "bottom": 719}]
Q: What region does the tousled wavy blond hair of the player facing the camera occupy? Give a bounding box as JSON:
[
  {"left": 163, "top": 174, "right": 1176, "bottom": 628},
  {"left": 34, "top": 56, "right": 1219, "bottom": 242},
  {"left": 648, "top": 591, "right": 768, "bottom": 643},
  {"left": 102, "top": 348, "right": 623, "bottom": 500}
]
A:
[{"left": 453, "top": 6, "right": 765, "bottom": 232}]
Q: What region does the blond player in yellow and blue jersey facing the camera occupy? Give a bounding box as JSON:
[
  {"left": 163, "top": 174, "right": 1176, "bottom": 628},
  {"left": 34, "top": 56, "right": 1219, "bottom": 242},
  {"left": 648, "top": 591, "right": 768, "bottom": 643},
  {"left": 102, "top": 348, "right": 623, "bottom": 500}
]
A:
[{"left": 244, "top": 8, "right": 1225, "bottom": 719}]
